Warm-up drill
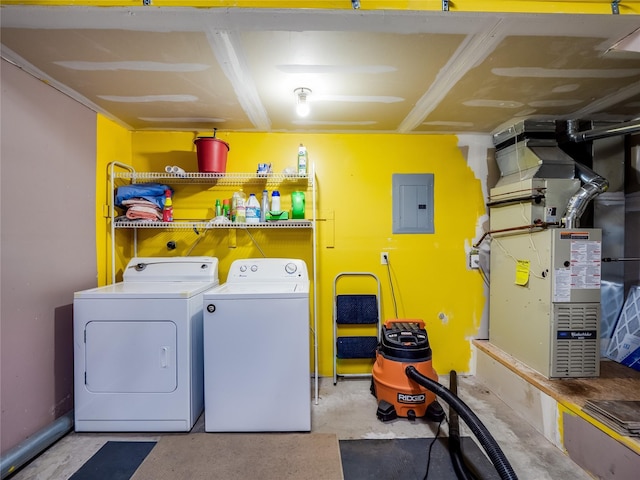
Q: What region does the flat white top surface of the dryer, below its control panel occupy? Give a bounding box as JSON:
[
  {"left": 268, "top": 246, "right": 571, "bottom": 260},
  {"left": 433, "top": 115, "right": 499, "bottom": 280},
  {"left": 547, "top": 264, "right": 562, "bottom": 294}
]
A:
[{"left": 74, "top": 280, "right": 219, "bottom": 299}]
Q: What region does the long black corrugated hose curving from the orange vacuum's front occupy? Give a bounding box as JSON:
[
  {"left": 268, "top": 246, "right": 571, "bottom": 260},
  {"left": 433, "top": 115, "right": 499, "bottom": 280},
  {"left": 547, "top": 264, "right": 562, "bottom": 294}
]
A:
[{"left": 405, "top": 365, "right": 518, "bottom": 480}]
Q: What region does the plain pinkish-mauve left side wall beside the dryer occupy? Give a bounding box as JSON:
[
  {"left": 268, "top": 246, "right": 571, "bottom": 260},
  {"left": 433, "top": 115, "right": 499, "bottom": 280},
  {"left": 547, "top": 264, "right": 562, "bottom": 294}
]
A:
[{"left": 0, "top": 60, "right": 97, "bottom": 452}]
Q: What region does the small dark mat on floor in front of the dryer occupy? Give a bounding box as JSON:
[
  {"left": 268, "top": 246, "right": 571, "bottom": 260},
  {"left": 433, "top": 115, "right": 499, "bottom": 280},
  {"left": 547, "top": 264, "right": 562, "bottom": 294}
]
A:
[{"left": 69, "top": 442, "right": 156, "bottom": 480}]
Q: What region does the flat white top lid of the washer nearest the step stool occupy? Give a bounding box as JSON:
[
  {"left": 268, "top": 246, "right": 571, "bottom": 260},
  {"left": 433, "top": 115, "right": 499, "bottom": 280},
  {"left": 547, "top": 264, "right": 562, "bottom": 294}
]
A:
[{"left": 204, "top": 282, "right": 309, "bottom": 299}]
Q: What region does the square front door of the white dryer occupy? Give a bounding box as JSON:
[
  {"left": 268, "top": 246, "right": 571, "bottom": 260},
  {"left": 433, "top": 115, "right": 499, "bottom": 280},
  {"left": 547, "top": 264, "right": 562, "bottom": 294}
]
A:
[{"left": 85, "top": 321, "right": 177, "bottom": 393}]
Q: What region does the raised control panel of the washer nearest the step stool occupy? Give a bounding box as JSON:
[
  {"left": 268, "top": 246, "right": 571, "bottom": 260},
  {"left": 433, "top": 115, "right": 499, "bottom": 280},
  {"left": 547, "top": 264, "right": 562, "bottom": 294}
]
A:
[{"left": 227, "top": 258, "right": 309, "bottom": 283}]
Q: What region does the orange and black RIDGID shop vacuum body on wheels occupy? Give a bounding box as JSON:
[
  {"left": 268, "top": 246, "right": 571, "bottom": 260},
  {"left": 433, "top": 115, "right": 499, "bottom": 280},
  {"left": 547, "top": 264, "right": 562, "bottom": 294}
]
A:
[{"left": 371, "top": 320, "right": 444, "bottom": 422}]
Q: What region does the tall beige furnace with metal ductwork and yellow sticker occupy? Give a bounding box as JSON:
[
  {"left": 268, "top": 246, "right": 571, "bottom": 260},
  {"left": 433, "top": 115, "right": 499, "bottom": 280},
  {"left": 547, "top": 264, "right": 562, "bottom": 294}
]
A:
[{"left": 489, "top": 122, "right": 606, "bottom": 378}]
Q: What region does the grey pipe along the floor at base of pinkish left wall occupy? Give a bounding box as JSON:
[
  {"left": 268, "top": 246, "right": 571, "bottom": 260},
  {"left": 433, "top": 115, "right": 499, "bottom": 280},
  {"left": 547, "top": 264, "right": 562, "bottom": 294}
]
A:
[{"left": 0, "top": 410, "right": 73, "bottom": 479}]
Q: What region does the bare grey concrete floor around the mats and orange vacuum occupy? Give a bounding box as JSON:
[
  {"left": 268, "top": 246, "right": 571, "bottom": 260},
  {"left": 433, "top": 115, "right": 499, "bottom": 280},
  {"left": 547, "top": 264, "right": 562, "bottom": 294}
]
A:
[{"left": 10, "top": 376, "right": 592, "bottom": 480}]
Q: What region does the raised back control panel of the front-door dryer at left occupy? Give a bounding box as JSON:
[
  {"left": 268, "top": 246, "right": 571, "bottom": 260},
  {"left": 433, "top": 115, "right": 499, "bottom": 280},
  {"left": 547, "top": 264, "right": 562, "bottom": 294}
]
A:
[{"left": 122, "top": 257, "right": 218, "bottom": 283}]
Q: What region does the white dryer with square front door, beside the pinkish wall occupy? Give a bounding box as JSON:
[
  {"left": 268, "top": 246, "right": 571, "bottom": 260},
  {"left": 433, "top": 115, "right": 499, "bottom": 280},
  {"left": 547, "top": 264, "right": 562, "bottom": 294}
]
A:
[{"left": 73, "top": 257, "right": 219, "bottom": 432}]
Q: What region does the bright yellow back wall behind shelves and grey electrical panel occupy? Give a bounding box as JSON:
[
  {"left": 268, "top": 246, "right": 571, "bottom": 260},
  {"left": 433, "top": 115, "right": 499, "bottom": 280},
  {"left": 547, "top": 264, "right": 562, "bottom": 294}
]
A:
[{"left": 99, "top": 130, "right": 485, "bottom": 376}]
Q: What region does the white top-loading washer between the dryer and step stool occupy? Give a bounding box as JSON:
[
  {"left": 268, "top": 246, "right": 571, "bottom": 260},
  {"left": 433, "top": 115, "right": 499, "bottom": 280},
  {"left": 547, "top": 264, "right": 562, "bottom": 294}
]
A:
[{"left": 203, "top": 258, "right": 311, "bottom": 432}]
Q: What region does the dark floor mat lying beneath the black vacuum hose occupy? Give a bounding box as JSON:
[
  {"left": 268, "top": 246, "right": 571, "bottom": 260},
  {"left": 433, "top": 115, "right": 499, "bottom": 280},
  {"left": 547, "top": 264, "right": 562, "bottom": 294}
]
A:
[{"left": 340, "top": 437, "right": 500, "bottom": 480}]
